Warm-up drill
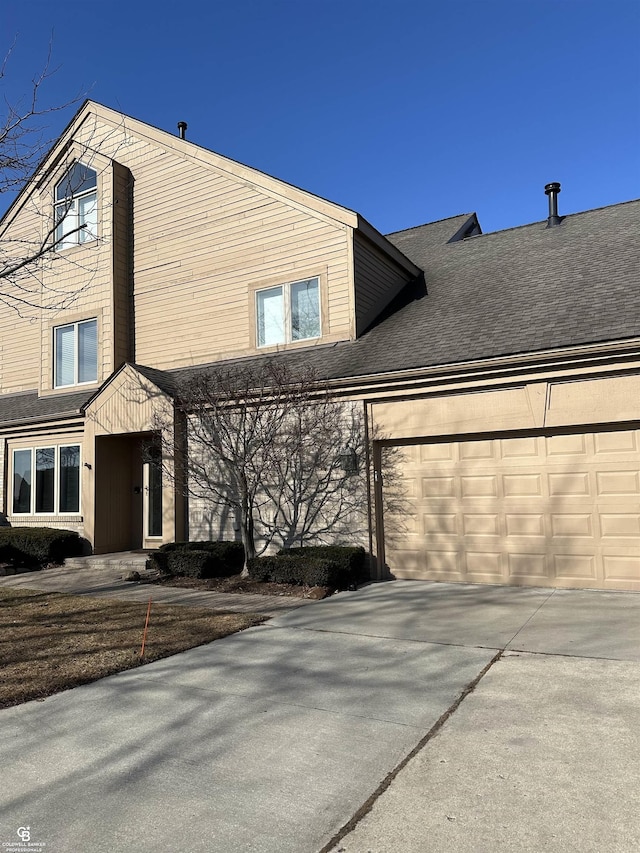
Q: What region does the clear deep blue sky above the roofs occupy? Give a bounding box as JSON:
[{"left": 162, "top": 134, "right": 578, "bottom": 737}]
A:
[{"left": 0, "top": 0, "right": 640, "bottom": 232}]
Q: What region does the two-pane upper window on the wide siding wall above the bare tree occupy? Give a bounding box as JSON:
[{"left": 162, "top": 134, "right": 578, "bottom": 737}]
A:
[{"left": 256, "top": 278, "right": 321, "bottom": 347}]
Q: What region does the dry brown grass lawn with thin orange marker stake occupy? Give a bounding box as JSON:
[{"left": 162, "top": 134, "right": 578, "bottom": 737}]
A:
[{"left": 0, "top": 588, "right": 265, "bottom": 708}]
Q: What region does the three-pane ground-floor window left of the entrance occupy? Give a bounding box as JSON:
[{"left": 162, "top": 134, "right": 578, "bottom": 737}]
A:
[{"left": 11, "top": 444, "right": 80, "bottom": 515}]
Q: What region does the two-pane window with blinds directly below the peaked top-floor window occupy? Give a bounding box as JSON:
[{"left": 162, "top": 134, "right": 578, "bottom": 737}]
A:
[{"left": 53, "top": 319, "right": 98, "bottom": 388}]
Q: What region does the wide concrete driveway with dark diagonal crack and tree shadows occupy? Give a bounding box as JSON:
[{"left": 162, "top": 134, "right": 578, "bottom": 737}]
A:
[{"left": 0, "top": 581, "right": 640, "bottom": 853}]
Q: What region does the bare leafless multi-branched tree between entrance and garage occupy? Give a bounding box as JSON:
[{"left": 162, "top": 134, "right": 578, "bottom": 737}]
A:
[{"left": 158, "top": 359, "right": 367, "bottom": 573}]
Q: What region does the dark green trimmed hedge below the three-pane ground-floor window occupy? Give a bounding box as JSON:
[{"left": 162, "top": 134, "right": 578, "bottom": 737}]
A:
[{"left": 0, "top": 527, "right": 83, "bottom": 566}]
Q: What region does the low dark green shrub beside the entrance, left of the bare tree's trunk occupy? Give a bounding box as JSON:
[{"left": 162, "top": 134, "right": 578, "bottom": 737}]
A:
[{"left": 147, "top": 541, "right": 244, "bottom": 578}]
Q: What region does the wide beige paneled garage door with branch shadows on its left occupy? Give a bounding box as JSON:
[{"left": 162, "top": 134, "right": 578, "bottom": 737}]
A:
[{"left": 384, "top": 429, "right": 640, "bottom": 590}]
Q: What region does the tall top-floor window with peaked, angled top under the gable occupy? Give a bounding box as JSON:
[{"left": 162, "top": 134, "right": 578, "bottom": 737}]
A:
[{"left": 55, "top": 163, "right": 98, "bottom": 249}]
